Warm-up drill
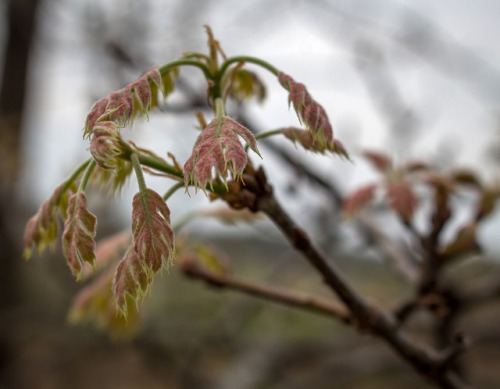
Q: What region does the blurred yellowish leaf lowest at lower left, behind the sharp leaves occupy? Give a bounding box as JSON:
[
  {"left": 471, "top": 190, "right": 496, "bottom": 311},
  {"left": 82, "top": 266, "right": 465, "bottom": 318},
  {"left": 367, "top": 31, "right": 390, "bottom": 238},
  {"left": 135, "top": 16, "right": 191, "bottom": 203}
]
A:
[{"left": 68, "top": 269, "right": 140, "bottom": 339}]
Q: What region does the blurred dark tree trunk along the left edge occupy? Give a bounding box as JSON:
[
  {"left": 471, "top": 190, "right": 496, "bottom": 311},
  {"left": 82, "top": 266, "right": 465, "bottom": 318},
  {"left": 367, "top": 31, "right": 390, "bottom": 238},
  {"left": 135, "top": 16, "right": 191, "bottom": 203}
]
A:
[{"left": 0, "top": 0, "right": 39, "bottom": 376}]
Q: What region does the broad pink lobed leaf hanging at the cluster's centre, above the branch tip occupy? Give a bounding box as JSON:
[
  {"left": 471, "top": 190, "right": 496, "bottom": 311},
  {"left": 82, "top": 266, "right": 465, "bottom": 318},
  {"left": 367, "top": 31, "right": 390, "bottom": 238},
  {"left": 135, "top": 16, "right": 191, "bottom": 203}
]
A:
[{"left": 184, "top": 116, "right": 260, "bottom": 190}]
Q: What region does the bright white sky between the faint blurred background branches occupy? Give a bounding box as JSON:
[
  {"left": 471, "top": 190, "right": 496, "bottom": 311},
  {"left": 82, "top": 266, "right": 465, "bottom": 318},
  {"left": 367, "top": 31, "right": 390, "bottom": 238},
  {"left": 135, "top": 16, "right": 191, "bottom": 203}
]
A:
[{"left": 10, "top": 0, "right": 500, "bottom": 253}]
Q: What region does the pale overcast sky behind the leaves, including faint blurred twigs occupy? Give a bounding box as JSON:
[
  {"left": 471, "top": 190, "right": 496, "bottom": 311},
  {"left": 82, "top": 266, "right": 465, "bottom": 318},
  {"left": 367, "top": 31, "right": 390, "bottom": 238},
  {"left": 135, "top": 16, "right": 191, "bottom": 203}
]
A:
[{"left": 9, "top": 0, "right": 500, "bottom": 252}]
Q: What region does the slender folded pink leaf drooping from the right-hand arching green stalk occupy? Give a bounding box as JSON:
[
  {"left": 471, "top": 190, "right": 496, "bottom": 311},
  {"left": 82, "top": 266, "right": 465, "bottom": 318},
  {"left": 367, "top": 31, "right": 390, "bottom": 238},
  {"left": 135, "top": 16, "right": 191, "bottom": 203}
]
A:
[{"left": 278, "top": 72, "right": 333, "bottom": 147}]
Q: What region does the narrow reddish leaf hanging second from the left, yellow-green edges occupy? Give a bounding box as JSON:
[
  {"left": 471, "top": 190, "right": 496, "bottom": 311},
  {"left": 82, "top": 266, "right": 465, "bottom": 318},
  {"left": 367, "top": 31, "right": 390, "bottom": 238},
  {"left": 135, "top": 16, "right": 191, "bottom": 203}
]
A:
[{"left": 62, "top": 192, "right": 97, "bottom": 278}]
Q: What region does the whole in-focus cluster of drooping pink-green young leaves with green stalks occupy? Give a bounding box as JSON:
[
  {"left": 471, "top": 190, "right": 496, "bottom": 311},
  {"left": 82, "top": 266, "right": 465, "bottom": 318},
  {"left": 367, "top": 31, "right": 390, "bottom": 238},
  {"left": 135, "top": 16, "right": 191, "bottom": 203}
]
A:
[{"left": 24, "top": 28, "right": 347, "bottom": 336}]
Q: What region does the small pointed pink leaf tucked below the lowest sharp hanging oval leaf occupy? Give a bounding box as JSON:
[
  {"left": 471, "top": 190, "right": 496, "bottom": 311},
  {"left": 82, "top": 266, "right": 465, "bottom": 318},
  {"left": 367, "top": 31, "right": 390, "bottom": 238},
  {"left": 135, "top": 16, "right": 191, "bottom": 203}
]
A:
[{"left": 113, "top": 246, "right": 151, "bottom": 317}]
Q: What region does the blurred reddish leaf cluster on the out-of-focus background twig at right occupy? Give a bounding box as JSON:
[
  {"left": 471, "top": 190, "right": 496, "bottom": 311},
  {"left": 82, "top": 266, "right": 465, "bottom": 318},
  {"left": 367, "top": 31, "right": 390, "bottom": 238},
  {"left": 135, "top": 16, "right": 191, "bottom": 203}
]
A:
[{"left": 343, "top": 151, "right": 500, "bottom": 261}]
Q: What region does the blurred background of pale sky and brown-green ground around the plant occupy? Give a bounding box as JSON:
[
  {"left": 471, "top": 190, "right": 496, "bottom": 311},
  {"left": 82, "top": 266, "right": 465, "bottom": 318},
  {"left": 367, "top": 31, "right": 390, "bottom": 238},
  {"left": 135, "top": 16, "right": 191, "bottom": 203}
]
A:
[{"left": 0, "top": 0, "right": 500, "bottom": 389}]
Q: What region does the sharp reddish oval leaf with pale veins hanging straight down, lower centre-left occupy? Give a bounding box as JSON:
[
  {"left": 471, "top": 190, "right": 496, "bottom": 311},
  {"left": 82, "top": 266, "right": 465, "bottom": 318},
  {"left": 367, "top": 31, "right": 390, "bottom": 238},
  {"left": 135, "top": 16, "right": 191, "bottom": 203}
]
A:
[{"left": 132, "top": 189, "right": 175, "bottom": 279}]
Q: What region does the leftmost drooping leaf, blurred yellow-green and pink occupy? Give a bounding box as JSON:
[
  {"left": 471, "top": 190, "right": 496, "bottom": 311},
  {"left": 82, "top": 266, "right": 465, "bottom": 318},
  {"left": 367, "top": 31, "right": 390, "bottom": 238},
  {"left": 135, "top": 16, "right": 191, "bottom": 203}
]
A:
[{"left": 24, "top": 185, "right": 73, "bottom": 259}]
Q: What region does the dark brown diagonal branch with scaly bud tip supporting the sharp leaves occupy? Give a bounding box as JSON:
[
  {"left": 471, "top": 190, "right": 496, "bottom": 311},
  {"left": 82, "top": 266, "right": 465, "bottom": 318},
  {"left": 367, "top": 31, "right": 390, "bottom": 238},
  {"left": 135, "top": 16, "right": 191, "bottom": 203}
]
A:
[{"left": 221, "top": 166, "right": 466, "bottom": 388}]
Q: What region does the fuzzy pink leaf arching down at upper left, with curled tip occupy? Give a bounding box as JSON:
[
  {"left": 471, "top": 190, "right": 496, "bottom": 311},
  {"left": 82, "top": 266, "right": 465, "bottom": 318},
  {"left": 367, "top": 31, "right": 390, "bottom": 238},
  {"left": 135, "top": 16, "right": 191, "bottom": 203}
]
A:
[{"left": 83, "top": 68, "right": 163, "bottom": 169}]
